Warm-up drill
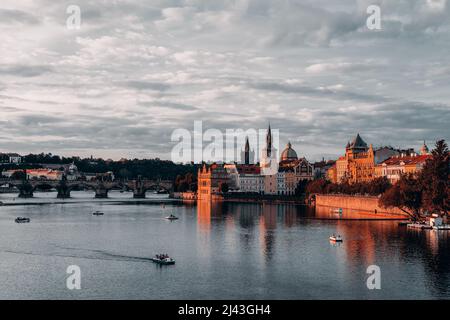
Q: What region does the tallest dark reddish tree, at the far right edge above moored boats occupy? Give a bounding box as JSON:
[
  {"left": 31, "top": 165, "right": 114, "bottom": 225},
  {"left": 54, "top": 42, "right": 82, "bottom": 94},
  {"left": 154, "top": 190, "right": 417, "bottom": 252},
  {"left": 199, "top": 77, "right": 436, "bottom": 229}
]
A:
[{"left": 419, "top": 140, "right": 450, "bottom": 215}]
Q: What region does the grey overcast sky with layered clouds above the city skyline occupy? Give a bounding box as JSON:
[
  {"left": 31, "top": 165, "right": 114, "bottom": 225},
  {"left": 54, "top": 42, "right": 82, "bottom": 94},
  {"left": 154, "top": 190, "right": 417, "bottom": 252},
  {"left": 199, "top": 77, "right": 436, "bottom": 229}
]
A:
[{"left": 0, "top": 0, "right": 450, "bottom": 160}]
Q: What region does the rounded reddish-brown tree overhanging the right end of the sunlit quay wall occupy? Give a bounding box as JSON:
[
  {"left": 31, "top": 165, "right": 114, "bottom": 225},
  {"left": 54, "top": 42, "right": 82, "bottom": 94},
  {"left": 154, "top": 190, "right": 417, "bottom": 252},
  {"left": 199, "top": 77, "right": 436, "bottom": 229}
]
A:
[{"left": 379, "top": 174, "right": 422, "bottom": 221}]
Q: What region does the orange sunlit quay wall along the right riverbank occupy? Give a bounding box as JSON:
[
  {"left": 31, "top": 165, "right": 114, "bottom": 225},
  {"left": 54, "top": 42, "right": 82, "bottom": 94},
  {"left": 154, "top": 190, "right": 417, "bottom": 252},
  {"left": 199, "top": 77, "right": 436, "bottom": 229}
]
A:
[{"left": 315, "top": 194, "right": 408, "bottom": 218}]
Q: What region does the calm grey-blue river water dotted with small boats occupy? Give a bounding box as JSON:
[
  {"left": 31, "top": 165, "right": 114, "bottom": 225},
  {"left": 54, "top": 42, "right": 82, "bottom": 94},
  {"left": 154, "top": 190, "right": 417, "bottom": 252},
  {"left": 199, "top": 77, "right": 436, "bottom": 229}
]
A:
[{"left": 0, "top": 192, "right": 450, "bottom": 299}]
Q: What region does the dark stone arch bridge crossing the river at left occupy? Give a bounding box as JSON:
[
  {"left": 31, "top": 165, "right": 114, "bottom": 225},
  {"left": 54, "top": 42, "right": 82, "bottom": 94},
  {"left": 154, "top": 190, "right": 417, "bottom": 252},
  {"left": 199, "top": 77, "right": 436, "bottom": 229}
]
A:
[{"left": 0, "top": 178, "right": 173, "bottom": 199}]
